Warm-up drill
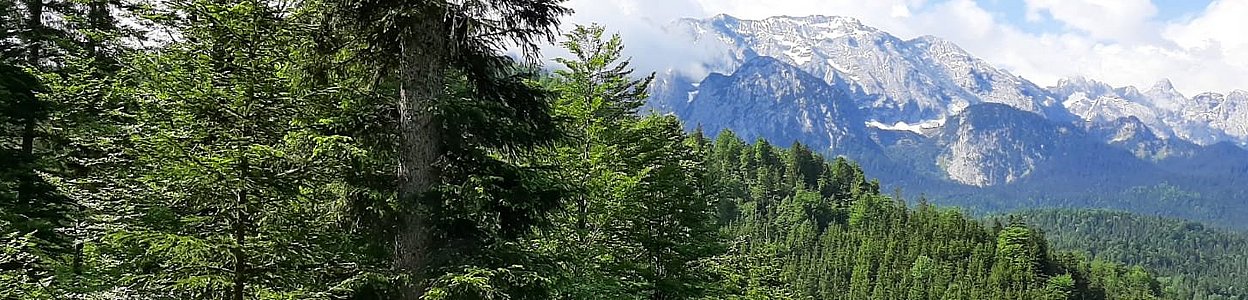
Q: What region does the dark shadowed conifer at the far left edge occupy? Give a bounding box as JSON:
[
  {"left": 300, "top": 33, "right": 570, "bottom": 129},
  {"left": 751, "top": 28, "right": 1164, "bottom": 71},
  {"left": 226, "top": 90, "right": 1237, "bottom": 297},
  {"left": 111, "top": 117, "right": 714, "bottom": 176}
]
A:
[{"left": 0, "top": 0, "right": 91, "bottom": 292}]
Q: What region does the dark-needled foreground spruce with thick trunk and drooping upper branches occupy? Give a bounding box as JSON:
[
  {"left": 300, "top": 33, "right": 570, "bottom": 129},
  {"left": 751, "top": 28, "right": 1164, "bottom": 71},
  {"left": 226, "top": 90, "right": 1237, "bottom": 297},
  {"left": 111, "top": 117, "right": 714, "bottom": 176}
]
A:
[{"left": 316, "top": 0, "right": 570, "bottom": 300}]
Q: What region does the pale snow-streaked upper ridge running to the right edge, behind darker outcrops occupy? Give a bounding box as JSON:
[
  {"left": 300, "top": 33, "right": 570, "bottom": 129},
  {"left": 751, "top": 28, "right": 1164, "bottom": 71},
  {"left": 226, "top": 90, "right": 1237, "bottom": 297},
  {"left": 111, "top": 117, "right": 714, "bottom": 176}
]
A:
[{"left": 651, "top": 15, "right": 1248, "bottom": 145}]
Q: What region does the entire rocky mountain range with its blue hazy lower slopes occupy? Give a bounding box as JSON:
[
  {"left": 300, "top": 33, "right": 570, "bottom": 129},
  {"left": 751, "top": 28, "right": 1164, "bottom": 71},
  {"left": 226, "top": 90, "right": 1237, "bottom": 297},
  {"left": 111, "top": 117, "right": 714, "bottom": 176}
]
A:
[{"left": 648, "top": 15, "right": 1248, "bottom": 226}]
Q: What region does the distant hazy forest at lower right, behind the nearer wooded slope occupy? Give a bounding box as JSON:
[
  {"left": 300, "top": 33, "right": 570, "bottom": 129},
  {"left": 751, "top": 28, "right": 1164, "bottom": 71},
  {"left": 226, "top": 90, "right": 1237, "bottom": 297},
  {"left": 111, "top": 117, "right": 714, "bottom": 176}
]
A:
[{"left": 1016, "top": 210, "right": 1248, "bottom": 299}]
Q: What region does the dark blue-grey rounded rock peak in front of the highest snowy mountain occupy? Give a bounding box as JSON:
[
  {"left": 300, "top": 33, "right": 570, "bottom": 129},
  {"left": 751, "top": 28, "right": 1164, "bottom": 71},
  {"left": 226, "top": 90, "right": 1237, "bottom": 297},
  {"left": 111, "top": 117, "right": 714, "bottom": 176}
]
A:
[{"left": 669, "top": 56, "right": 874, "bottom": 155}]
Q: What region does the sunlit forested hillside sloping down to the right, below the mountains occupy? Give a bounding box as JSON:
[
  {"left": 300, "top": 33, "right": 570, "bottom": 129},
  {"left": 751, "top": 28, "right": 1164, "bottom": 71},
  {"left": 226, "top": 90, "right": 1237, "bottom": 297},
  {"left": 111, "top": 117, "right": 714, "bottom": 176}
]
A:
[{"left": 709, "top": 133, "right": 1161, "bottom": 299}]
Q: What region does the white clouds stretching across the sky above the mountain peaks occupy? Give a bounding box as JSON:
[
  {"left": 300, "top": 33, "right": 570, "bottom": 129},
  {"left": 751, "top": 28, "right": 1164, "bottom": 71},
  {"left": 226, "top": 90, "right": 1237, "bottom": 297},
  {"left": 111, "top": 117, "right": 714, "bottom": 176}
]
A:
[{"left": 548, "top": 0, "right": 1248, "bottom": 95}]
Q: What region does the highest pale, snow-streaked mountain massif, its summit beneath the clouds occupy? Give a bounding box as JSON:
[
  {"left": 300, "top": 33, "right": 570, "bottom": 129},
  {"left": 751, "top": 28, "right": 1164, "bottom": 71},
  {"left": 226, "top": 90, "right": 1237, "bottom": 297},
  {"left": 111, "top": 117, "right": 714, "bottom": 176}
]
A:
[{"left": 674, "top": 15, "right": 1065, "bottom": 124}]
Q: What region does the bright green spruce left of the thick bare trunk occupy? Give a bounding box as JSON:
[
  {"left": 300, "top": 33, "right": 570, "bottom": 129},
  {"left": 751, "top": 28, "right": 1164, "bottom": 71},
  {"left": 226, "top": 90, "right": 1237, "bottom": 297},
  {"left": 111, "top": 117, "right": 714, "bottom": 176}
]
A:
[{"left": 97, "top": 0, "right": 379, "bottom": 296}]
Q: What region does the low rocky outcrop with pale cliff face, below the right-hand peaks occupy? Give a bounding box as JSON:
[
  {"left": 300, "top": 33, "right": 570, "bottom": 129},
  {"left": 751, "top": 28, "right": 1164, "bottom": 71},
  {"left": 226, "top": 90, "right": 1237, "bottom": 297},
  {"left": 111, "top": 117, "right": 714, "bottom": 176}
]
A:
[{"left": 935, "top": 104, "right": 1164, "bottom": 186}]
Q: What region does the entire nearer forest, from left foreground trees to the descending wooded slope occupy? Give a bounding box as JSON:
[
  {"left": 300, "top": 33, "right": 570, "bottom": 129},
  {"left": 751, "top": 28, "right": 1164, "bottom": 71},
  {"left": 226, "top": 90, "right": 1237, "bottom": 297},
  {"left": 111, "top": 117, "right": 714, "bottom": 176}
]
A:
[{"left": 0, "top": 0, "right": 1173, "bottom": 300}]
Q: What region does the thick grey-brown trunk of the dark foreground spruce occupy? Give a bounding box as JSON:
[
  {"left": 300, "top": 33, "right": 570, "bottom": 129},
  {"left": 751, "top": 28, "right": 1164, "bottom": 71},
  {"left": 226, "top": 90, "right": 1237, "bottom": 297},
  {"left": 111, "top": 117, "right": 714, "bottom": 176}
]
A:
[{"left": 393, "top": 18, "right": 449, "bottom": 300}]
